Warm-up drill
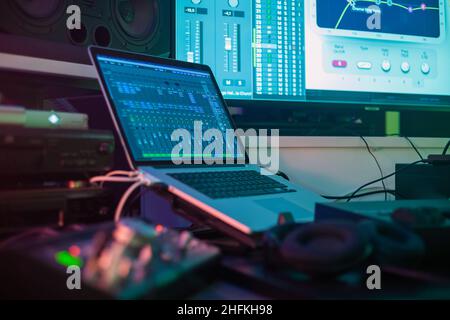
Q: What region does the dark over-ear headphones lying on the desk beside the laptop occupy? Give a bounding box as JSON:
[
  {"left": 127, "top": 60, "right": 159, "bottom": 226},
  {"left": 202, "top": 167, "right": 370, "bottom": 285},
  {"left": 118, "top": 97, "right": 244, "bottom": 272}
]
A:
[{"left": 263, "top": 220, "right": 425, "bottom": 276}]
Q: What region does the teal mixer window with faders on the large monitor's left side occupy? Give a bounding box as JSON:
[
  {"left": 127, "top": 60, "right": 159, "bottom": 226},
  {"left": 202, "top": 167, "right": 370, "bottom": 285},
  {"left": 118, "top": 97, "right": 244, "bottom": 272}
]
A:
[{"left": 176, "top": 0, "right": 305, "bottom": 100}]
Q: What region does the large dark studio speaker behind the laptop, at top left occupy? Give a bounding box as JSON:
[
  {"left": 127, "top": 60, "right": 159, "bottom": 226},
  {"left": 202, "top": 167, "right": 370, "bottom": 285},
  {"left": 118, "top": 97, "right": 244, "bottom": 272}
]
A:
[{"left": 0, "top": 0, "right": 172, "bottom": 63}]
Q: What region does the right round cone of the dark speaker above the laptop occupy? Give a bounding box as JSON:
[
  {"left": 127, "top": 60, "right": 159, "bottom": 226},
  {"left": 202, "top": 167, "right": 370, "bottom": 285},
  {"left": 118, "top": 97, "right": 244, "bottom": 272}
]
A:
[{"left": 114, "top": 0, "right": 159, "bottom": 41}]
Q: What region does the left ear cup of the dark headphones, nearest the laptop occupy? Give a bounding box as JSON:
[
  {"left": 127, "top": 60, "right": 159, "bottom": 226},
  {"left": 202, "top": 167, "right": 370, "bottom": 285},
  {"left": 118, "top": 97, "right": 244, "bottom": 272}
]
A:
[{"left": 280, "top": 222, "right": 370, "bottom": 276}]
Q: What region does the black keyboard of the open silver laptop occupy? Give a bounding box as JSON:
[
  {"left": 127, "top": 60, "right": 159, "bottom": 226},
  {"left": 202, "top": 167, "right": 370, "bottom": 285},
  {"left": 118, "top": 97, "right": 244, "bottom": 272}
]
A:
[{"left": 169, "top": 170, "right": 296, "bottom": 199}]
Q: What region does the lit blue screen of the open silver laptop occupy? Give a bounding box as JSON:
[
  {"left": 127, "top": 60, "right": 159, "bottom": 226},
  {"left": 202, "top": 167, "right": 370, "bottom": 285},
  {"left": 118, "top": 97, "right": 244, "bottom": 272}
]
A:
[{"left": 97, "top": 55, "right": 244, "bottom": 163}]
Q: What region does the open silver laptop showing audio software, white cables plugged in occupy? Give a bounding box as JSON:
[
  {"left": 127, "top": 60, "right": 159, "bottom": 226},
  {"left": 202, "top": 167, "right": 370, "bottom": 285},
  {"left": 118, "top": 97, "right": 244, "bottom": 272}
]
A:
[{"left": 89, "top": 47, "right": 327, "bottom": 245}]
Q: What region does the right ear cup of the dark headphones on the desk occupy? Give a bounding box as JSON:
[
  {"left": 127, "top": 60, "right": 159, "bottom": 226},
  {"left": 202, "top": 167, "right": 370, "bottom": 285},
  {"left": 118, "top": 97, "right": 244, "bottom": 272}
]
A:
[{"left": 360, "top": 221, "right": 425, "bottom": 267}]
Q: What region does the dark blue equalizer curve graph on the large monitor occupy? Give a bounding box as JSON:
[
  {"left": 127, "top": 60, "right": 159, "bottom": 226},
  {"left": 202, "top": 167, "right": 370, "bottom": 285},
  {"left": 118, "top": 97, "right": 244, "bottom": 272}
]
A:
[{"left": 312, "top": 0, "right": 446, "bottom": 43}]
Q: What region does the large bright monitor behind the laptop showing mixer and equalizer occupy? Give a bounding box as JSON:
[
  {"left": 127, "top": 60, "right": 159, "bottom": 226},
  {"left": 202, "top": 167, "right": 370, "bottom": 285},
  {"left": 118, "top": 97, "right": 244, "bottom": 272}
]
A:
[{"left": 175, "top": 0, "right": 450, "bottom": 110}]
